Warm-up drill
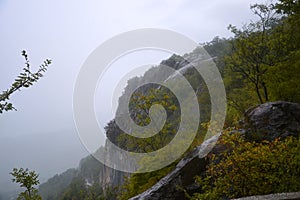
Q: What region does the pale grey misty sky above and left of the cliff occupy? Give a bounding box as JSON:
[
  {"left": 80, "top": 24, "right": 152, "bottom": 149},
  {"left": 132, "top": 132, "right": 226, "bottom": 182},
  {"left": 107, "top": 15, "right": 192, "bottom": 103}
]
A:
[{"left": 0, "top": 0, "right": 268, "bottom": 192}]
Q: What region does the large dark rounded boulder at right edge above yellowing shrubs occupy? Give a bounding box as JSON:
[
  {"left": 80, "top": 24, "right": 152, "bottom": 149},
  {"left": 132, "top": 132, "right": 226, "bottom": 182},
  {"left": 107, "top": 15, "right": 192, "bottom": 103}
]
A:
[{"left": 245, "top": 101, "right": 300, "bottom": 141}]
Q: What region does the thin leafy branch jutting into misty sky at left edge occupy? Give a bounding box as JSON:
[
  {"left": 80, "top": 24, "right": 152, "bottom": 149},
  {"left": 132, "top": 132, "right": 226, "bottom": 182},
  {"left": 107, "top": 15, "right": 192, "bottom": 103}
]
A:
[{"left": 0, "top": 50, "right": 51, "bottom": 114}]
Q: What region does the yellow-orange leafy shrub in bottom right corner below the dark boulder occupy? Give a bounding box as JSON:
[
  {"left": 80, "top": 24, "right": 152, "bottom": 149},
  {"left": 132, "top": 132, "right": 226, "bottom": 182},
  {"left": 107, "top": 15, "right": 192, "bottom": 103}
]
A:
[{"left": 191, "top": 134, "right": 300, "bottom": 199}]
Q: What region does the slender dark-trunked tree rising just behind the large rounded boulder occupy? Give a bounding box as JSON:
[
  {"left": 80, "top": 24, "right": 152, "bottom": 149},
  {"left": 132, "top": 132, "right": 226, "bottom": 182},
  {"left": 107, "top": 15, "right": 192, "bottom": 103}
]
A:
[{"left": 226, "top": 4, "right": 278, "bottom": 103}]
